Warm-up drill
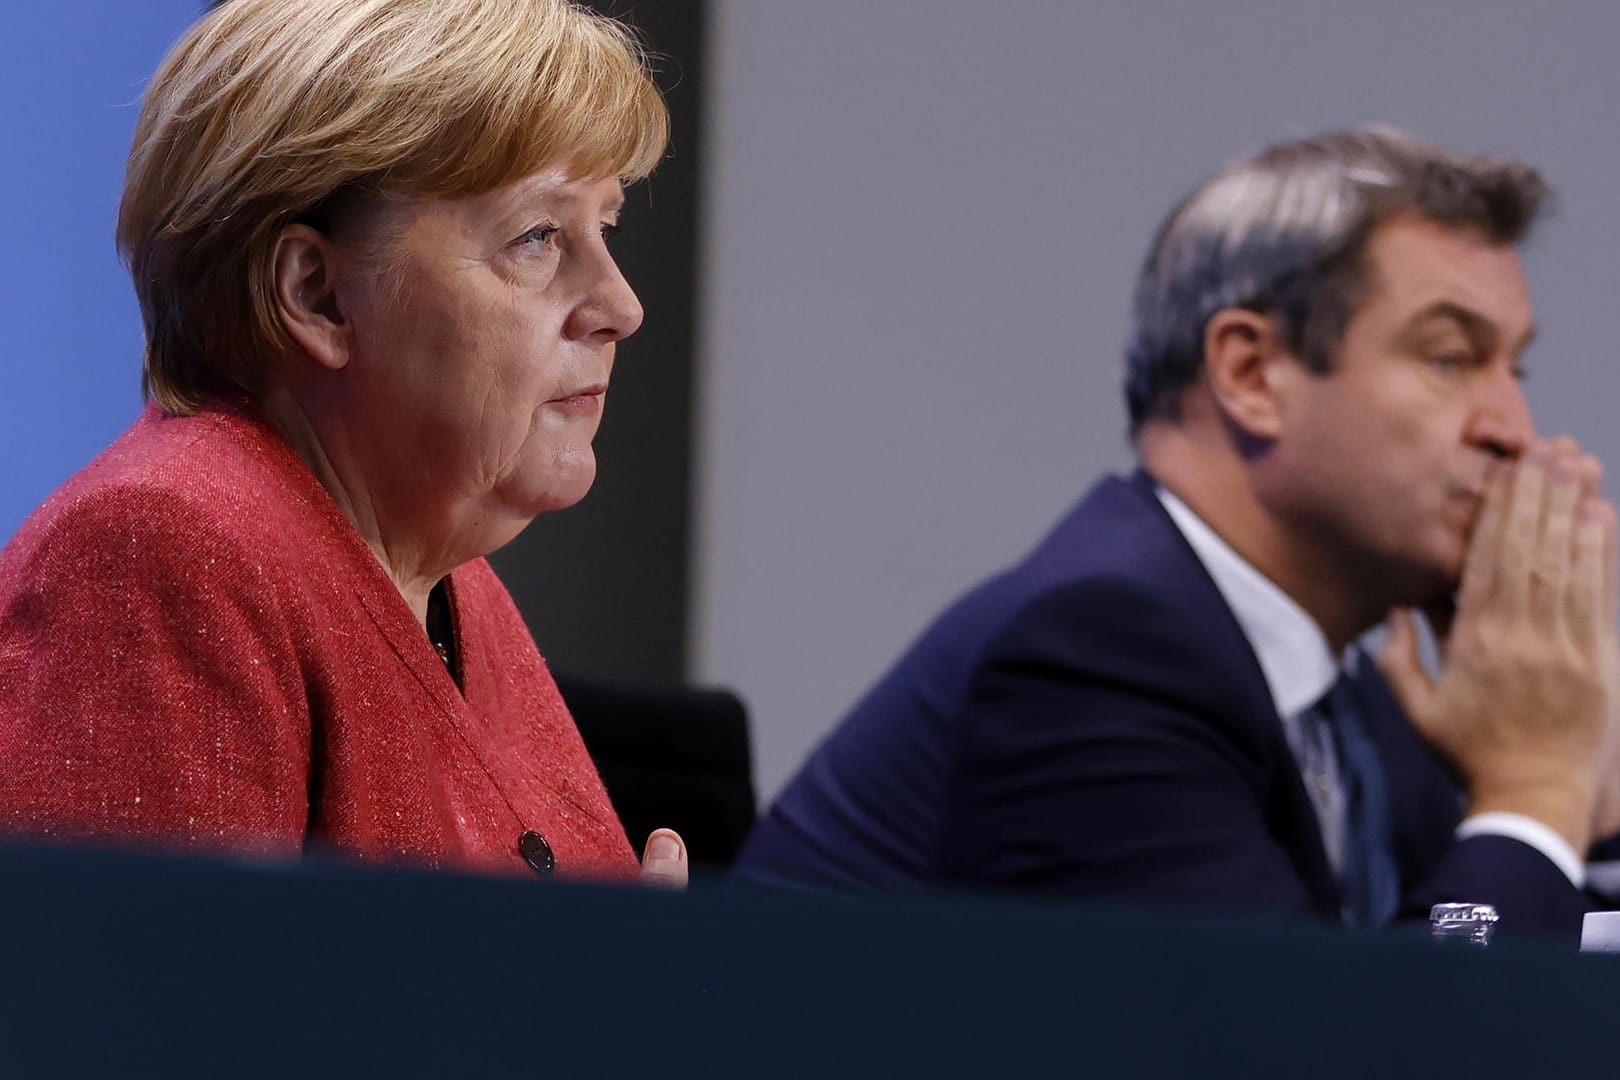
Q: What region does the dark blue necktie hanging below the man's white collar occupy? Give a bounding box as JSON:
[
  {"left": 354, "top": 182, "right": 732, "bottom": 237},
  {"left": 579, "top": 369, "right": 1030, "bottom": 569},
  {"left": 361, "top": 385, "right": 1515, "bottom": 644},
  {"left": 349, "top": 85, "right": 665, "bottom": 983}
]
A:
[{"left": 1302, "top": 675, "right": 1400, "bottom": 926}]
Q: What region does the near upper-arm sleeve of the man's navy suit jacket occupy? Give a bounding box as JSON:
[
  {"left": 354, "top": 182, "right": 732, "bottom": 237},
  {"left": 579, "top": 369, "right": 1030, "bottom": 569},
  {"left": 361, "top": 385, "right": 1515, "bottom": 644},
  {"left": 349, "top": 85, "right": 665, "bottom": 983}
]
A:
[{"left": 943, "top": 594, "right": 1332, "bottom": 915}]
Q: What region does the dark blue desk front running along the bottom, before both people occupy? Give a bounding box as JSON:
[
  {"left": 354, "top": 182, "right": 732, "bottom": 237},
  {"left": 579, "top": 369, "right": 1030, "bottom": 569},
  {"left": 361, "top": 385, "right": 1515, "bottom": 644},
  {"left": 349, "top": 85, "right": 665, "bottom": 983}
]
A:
[{"left": 0, "top": 848, "right": 1620, "bottom": 1080}]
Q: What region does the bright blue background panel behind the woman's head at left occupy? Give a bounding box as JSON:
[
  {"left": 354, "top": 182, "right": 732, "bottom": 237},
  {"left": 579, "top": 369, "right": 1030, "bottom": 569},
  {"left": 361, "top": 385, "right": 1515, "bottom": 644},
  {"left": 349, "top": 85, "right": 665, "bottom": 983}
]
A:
[{"left": 0, "top": 0, "right": 201, "bottom": 539}]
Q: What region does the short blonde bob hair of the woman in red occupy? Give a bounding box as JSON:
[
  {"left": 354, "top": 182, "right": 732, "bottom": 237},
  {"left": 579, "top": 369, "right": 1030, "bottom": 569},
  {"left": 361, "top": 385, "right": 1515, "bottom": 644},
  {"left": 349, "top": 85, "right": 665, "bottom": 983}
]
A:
[{"left": 118, "top": 0, "right": 669, "bottom": 415}]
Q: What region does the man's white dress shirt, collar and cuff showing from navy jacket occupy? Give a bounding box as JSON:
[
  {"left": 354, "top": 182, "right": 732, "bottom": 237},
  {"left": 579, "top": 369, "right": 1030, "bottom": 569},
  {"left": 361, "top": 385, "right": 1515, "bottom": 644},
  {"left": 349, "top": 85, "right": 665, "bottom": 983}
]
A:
[{"left": 1155, "top": 487, "right": 1586, "bottom": 887}]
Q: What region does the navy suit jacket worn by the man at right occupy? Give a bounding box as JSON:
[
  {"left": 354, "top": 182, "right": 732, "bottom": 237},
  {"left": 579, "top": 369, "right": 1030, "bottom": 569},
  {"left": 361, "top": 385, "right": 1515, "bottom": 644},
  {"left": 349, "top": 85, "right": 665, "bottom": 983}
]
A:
[{"left": 739, "top": 473, "right": 1589, "bottom": 939}]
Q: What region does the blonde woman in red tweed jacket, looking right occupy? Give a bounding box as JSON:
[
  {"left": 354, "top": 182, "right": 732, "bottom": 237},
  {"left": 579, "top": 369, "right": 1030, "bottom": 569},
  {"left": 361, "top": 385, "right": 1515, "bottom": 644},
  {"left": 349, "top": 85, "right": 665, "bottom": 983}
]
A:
[{"left": 0, "top": 0, "right": 685, "bottom": 881}]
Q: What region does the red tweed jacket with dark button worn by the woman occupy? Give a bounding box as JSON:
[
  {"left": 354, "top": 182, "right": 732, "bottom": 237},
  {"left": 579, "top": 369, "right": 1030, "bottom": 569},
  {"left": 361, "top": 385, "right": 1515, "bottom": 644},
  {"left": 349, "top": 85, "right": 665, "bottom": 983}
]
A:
[{"left": 0, "top": 405, "right": 637, "bottom": 878}]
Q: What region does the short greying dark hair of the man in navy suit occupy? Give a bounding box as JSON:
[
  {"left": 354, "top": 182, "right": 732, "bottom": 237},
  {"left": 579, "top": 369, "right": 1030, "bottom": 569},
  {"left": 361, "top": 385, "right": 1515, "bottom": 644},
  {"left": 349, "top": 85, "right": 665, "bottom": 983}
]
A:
[{"left": 1124, "top": 128, "right": 1549, "bottom": 434}]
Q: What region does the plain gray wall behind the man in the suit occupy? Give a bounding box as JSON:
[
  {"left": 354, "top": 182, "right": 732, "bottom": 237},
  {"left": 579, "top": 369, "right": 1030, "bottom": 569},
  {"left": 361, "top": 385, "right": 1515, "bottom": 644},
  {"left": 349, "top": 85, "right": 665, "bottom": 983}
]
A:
[{"left": 690, "top": 0, "right": 1620, "bottom": 798}]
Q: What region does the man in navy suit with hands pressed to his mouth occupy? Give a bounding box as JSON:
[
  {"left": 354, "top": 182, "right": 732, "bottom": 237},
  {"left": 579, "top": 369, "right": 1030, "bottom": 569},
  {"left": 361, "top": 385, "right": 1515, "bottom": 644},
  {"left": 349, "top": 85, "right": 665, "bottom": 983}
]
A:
[{"left": 742, "top": 130, "right": 1620, "bottom": 933}]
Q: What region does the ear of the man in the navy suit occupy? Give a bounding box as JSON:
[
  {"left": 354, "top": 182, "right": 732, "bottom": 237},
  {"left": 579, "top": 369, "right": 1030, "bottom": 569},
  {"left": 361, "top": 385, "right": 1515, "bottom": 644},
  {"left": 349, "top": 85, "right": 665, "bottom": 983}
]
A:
[{"left": 1204, "top": 308, "right": 1299, "bottom": 442}]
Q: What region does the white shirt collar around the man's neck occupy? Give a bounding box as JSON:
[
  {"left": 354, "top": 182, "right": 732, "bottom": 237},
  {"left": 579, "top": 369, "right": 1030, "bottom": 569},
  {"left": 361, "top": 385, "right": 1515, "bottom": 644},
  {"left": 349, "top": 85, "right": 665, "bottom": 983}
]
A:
[{"left": 1153, "top": 486, "right": 1338, "bottom": 719}]
